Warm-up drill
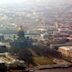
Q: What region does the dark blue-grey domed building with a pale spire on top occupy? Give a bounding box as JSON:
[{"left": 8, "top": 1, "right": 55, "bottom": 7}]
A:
[{"left": 10, "top": 26, "right": 32, "bottom": 49}]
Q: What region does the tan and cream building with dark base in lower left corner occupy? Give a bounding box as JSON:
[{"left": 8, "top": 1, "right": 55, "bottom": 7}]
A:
[{"left": 0, "top": 52, "right": 27, "bottom": 72}]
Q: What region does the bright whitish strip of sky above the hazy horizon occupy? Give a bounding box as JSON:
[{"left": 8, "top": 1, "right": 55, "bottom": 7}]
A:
[{"left": 0, "top": 0, "right": 72, "bottom": 4}]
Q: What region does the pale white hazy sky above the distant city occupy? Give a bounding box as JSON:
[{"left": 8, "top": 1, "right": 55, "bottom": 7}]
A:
[{"left": 0, "top": 0, "right": 72, "bottom": 6}]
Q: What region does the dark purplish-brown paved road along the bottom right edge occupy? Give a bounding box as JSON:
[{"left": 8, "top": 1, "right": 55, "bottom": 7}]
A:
[{"left": 35, "top": 67, "right": 72, "bottom": 72}]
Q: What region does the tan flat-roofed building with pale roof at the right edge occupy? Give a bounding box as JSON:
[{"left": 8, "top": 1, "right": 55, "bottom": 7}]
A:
[{"left": 58, "top": 46, "right": 72, "bottom": 62}]
